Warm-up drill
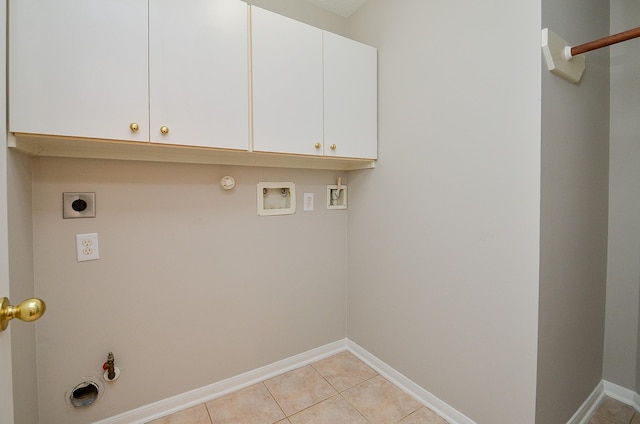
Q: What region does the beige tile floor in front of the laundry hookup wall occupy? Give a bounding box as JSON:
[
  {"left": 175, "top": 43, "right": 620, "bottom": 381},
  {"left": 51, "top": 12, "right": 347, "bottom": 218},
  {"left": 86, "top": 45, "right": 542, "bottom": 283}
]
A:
[{"left": 147, "top": 351, "right": 448, "bottom": 424}]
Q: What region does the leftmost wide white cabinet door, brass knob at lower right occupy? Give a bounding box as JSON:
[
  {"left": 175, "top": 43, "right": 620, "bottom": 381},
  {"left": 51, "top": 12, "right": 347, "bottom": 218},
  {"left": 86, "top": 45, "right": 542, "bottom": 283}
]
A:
[{"left": 9, "top": 0, "right": 149, "bottom": 141}]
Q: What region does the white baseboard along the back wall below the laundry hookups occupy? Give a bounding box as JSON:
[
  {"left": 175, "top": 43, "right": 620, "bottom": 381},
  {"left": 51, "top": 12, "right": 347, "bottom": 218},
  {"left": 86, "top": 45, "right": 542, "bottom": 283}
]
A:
[{"left": 94, "top": 339, "right": 347, "bottom": 424}]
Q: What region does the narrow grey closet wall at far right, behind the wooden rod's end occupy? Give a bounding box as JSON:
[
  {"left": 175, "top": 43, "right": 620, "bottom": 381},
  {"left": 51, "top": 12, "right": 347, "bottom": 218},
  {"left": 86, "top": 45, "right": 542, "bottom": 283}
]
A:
[{"left": 604, "top": 0, "right": 640, "bottom": 393}]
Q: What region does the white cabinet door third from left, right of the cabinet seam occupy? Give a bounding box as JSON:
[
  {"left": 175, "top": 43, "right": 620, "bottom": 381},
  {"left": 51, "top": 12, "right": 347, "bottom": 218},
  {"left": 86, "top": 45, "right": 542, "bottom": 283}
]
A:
[{"left": 251, "top": 6, "right": 323, "bottom": 155}]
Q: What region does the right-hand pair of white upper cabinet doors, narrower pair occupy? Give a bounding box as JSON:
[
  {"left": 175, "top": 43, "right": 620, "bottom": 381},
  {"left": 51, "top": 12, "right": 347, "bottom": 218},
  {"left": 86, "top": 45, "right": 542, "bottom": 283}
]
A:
[{"left": 251, "top": 6, "right": 377, "bottom": 159}]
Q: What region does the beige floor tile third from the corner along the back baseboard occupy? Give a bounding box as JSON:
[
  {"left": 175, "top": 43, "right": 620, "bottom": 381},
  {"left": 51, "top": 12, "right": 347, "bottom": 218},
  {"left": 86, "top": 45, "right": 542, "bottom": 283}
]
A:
[{"left": 206, "top": 383, "right": 285, "bottom": 424}]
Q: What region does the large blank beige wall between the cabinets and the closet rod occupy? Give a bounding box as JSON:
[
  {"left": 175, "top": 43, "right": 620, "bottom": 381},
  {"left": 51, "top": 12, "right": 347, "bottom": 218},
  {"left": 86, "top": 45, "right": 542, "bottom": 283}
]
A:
[{"left": 347, "top": 0, "right": 541, "bottom": 424}]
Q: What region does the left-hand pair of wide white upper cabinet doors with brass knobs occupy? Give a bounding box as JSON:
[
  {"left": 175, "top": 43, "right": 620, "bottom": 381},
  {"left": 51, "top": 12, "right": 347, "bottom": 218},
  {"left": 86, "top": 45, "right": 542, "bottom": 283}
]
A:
[{"left": 9, "top": 0, "right": 249, "bottom": 150}]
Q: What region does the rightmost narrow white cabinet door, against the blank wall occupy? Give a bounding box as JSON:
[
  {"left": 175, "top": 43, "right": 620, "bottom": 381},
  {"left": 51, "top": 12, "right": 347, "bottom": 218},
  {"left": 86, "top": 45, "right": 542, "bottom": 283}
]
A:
[{"left": 324, "top": 31, "right": 378, "bottom": 159}]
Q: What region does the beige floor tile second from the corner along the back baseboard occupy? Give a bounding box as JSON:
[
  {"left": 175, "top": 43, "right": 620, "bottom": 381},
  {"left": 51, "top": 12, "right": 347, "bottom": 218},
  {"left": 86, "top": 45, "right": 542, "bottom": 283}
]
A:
[{"left": 264, "top": 365, "right": 337, "bottom": 416}]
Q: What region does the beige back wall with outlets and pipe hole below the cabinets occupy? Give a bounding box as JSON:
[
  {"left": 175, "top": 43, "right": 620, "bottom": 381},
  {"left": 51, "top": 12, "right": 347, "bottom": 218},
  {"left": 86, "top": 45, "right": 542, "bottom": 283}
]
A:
[{"left": 33, "top": 158, "right": 348, "bottom": 424}]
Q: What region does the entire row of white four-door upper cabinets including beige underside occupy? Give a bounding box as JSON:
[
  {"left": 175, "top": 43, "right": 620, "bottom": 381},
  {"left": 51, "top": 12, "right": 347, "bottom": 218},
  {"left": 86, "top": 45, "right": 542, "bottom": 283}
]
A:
[{"left": 8, "top": 0, "right": 377, "bottom": 169}]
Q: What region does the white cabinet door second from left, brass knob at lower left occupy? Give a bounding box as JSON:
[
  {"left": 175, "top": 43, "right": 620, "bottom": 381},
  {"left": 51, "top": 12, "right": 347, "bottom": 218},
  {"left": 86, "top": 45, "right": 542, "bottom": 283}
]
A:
[{"left": 149, "top": 0, "right": 249, "bottom": 150}]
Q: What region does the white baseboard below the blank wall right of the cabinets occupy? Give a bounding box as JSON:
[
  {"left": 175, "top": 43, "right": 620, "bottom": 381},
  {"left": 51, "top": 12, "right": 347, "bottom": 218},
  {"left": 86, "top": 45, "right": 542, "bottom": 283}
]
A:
[{"left": 347, "top": 339, "right": 476, "bottom": 424}]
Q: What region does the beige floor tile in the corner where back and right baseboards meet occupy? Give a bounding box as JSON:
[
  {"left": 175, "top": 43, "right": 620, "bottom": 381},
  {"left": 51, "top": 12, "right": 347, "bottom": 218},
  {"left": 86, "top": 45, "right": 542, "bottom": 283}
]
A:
[{"left": 311, "top": 350, "right": 378, "bottom": 392}]
